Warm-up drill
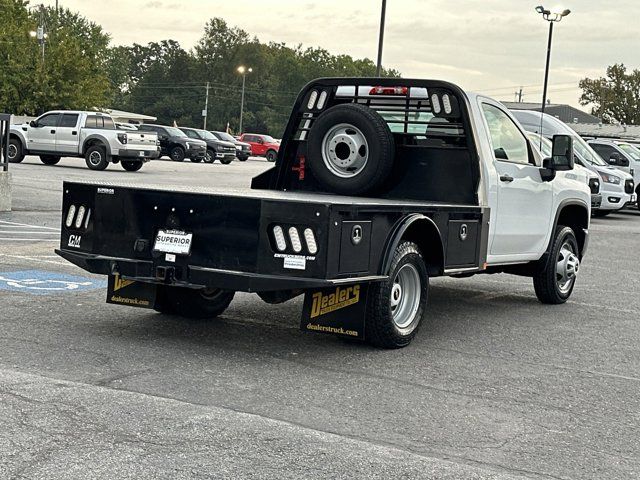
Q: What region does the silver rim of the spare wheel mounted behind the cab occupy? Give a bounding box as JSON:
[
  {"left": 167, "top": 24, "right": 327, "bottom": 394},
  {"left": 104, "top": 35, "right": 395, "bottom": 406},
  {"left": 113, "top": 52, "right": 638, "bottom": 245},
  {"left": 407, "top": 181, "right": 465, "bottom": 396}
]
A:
[{"left": 322, "top": 123, "right": 369, "bottom": 178}]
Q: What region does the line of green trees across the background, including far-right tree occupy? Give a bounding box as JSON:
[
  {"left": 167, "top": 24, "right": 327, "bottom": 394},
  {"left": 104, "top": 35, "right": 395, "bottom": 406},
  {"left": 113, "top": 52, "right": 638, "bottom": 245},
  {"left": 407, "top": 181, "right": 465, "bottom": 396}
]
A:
[{"left": 0, "top": 0, "right": 640, "bottom": 131}]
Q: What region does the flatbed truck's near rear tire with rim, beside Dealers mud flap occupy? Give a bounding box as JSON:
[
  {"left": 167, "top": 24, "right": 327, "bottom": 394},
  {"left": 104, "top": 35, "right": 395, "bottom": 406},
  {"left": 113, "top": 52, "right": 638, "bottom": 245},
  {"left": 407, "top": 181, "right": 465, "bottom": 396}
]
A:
[{"left": 365, "top": 242, "right": 429, "bottom": 348}]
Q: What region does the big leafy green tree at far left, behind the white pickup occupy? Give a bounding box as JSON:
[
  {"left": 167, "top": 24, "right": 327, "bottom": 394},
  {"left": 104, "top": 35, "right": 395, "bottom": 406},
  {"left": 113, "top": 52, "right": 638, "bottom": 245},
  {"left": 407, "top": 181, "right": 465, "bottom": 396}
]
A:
[{"left": 0, "top": 0, "right": 110, "bottom": 115}]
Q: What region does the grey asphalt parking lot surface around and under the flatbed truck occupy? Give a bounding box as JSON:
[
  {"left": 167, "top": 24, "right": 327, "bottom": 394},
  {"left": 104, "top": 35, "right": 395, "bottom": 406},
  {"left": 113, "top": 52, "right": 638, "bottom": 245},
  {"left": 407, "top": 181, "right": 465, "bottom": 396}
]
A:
[{"left": 0, "top": 158, "right": 640, "bottom": 479}]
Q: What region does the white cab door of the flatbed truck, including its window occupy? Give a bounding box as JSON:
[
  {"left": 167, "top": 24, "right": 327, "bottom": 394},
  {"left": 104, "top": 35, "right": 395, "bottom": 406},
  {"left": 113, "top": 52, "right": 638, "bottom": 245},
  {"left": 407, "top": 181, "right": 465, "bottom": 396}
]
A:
[{"left": 481, "top": 102, "right": 553, "bottom": 255}]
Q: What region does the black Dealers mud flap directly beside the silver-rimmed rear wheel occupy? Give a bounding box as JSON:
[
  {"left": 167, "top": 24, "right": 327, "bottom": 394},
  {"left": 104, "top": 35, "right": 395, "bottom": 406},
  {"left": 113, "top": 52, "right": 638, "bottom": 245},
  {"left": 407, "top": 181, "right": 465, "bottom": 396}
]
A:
[{"left": 300, "top": 283, "right": 369, "bottom": 340}]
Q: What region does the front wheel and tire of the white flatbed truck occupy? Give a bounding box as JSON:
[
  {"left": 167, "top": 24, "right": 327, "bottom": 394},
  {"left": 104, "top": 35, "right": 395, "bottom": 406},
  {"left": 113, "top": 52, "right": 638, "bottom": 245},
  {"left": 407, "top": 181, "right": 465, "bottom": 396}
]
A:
[{"left": 533, "top": 225, "right": 580, "bottom": 305}]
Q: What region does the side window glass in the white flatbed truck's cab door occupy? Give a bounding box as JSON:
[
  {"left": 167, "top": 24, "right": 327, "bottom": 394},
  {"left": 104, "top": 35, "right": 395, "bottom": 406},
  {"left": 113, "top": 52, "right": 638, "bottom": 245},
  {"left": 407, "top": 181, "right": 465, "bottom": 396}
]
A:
[{"left": 482, "top": 103, "right": 530, "bottom": 165}]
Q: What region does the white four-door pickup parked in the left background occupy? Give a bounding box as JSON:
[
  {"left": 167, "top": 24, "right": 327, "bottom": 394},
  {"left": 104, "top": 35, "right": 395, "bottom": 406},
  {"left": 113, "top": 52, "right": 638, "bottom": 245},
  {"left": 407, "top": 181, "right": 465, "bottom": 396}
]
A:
[{"left": 9, "top": 110, "right": 160, "bottom": 172}]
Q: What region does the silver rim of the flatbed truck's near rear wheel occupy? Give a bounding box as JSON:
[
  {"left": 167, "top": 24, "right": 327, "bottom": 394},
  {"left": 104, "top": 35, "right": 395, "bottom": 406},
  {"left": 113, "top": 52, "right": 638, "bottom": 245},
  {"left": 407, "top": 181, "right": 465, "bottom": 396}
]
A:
[{"left": 390, "top": 263, "right": 422, "bottom": 330}]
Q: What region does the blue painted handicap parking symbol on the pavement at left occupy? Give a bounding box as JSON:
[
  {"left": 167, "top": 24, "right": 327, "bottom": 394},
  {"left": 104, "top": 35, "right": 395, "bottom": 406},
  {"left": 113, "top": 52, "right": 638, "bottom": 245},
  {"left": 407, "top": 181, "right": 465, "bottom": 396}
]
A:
[{"left": 0, "top": 270, "right": 107, "bottom": 295}]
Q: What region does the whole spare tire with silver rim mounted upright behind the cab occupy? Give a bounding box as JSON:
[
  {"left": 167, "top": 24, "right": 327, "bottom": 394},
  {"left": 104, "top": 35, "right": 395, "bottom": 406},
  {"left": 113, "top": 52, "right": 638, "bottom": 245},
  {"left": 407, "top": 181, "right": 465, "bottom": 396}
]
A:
[{"left": 307, "top": 103, "right": 395, "bottom": 195}]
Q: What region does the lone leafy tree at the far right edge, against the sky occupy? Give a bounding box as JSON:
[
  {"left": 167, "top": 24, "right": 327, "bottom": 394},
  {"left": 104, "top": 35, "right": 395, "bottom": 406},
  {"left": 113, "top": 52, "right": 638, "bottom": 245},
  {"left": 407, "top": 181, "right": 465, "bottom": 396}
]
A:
[{"left": 580, "top": 64, "right": 640, "bottom": 125}]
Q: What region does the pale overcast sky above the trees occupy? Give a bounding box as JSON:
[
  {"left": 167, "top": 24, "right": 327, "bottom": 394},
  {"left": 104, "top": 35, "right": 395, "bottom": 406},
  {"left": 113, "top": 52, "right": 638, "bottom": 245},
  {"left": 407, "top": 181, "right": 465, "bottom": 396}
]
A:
[{"left": 38, "top": 0, "right": 640, "bottom": 106}]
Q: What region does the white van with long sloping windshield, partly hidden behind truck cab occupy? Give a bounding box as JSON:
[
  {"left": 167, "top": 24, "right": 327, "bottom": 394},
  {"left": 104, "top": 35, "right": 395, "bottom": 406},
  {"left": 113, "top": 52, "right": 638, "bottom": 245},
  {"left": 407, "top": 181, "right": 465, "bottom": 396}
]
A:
[{"left": 511, "top": 110, "right": 636, "bottom": 217}]
